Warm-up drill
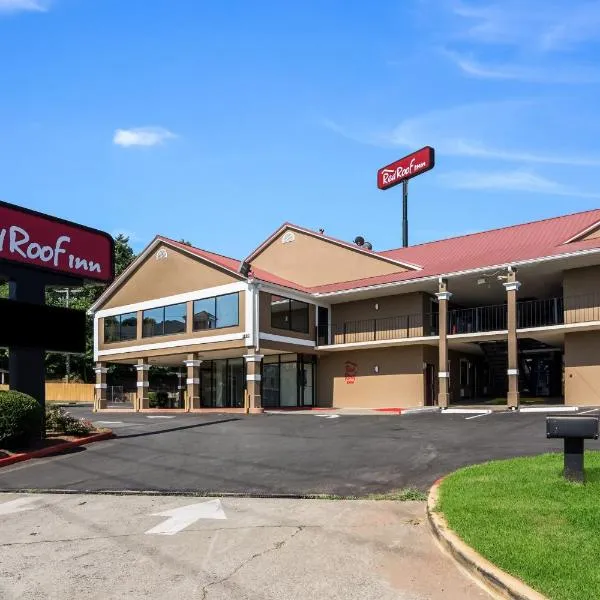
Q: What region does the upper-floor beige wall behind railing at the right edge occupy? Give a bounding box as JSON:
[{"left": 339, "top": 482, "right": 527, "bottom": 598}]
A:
[{"left": 563, "top": 266, "right": 600, "bottom": 323}]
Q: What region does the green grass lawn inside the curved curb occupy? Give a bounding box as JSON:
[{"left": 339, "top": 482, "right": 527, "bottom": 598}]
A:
[{"left": 438, "top": 452, "right": 600, "bottom": 600}]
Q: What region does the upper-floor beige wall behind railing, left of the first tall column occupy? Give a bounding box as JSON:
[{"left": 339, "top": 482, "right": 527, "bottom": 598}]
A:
[{"left": 331, "top": 292, "right": 427, "bottom": 344}]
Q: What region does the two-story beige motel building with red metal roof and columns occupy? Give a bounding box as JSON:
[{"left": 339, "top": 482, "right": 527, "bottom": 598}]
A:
[{"left": 91, "top": 210, "right": 600, "bottom": 413}]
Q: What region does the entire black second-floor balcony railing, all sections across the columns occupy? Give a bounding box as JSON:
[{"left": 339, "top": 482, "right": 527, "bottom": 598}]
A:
[{"left": 316, "top": 293, "right": 600, "bottom": 346}]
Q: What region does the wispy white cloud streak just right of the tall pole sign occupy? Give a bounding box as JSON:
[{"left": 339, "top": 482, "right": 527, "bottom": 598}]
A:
[{"left": 438, "top": 170, "right": 600, "bottom": 198}]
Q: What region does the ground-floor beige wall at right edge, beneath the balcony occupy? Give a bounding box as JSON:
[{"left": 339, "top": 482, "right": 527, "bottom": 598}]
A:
[{"left": 565, "top": 331, "right": 600, "bottom": 406}]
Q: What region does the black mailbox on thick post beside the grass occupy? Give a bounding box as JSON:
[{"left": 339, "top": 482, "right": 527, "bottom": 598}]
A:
[{"left": 546, "top": 416, "right": 600, "bottom": 481}]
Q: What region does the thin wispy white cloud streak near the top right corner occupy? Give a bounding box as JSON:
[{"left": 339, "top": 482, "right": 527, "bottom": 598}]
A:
[{"left": 444, "top": 52, "right": 600, "bottom": 84}]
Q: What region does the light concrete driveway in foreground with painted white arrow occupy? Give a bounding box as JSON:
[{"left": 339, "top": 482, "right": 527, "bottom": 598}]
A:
[{"left": 0, "top": 494, "right": 489, "bottom": 600}]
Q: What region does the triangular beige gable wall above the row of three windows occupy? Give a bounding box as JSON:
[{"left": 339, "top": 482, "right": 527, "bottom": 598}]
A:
[{"left": 100, "top": 247, "right": 240, "bottom": 308}]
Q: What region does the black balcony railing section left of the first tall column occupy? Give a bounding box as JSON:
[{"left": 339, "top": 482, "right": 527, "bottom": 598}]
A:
[{"left": 316, "top": 313, "right": 438, "bottom": 346}]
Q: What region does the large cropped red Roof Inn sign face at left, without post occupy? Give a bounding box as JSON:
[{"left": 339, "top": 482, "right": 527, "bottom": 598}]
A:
[{"left": 0, "top": 202, "right": 114, "bottom": 282}]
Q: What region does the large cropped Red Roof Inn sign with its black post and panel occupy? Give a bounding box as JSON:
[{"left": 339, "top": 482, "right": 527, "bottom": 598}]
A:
[{"left": 0, "top": 202, "right": 114, "bottom": 406}]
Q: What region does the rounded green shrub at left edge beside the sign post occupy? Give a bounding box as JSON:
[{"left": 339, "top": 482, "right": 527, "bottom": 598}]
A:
[{"left": 0, "top": 390, "right": 44, "bottom": 448}]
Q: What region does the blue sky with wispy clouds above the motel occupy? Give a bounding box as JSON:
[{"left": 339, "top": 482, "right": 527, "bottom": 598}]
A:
[{"left": 0, "top": 0, "right": 600, "bottom": 258}]
